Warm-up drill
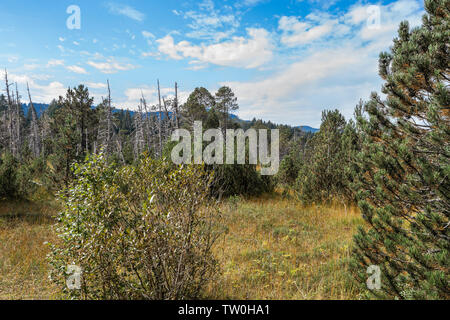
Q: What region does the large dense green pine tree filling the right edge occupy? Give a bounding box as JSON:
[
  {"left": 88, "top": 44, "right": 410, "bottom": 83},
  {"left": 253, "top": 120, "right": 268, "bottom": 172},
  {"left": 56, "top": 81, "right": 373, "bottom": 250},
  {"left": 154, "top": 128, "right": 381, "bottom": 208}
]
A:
[{"left": 354, "top": 0, "right": 450, "bottom": 299}]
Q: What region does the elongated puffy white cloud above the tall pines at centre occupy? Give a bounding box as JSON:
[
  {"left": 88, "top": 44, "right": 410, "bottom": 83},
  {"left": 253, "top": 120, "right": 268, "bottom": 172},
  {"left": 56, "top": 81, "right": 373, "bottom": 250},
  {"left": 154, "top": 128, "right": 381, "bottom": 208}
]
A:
[{"left": 156, "top": 28, "right": 273, "bottom": 69}]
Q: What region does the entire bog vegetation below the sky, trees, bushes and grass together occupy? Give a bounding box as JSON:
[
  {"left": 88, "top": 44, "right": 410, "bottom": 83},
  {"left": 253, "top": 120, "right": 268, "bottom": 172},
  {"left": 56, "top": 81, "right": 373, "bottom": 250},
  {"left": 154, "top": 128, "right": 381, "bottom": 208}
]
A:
[{"left": 0, "top": 0, "right": 450, "bottom": 299}]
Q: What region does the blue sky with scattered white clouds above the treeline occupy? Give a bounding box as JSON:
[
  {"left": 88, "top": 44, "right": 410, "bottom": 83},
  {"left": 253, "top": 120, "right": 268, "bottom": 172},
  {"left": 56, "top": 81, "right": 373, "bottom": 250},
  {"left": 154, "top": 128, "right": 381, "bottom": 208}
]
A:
[{"left": 0, "top": 0, "right": 425, "bottom": 127}]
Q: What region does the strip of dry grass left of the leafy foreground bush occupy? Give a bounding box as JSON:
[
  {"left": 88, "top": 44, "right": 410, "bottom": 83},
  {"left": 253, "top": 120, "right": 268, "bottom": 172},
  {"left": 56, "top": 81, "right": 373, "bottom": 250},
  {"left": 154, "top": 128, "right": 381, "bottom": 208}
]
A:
[{"left": 0, "top": 202, "right": 56, "bottom": 299}]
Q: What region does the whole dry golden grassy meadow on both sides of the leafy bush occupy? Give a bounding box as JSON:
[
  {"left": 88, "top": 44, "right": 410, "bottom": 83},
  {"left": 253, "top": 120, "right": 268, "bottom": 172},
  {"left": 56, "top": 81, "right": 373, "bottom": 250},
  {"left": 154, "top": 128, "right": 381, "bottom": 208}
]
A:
[{"left": 0, "top": 195, "right": 363, "bottom": 300}]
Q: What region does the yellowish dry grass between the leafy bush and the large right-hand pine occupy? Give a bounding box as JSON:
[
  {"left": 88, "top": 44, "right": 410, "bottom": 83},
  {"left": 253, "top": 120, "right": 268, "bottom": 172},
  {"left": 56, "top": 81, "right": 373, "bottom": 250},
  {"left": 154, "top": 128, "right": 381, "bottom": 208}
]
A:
[{"left": 209, "top": 197, "right": 363, "bottom": 300}]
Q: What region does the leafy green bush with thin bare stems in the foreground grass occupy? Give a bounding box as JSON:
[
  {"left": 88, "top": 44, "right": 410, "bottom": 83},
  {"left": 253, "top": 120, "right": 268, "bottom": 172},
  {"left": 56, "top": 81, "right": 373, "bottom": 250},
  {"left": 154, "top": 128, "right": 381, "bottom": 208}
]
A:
[{"left": 49, "top": 155, "right": 220, "bottom": 299}]
